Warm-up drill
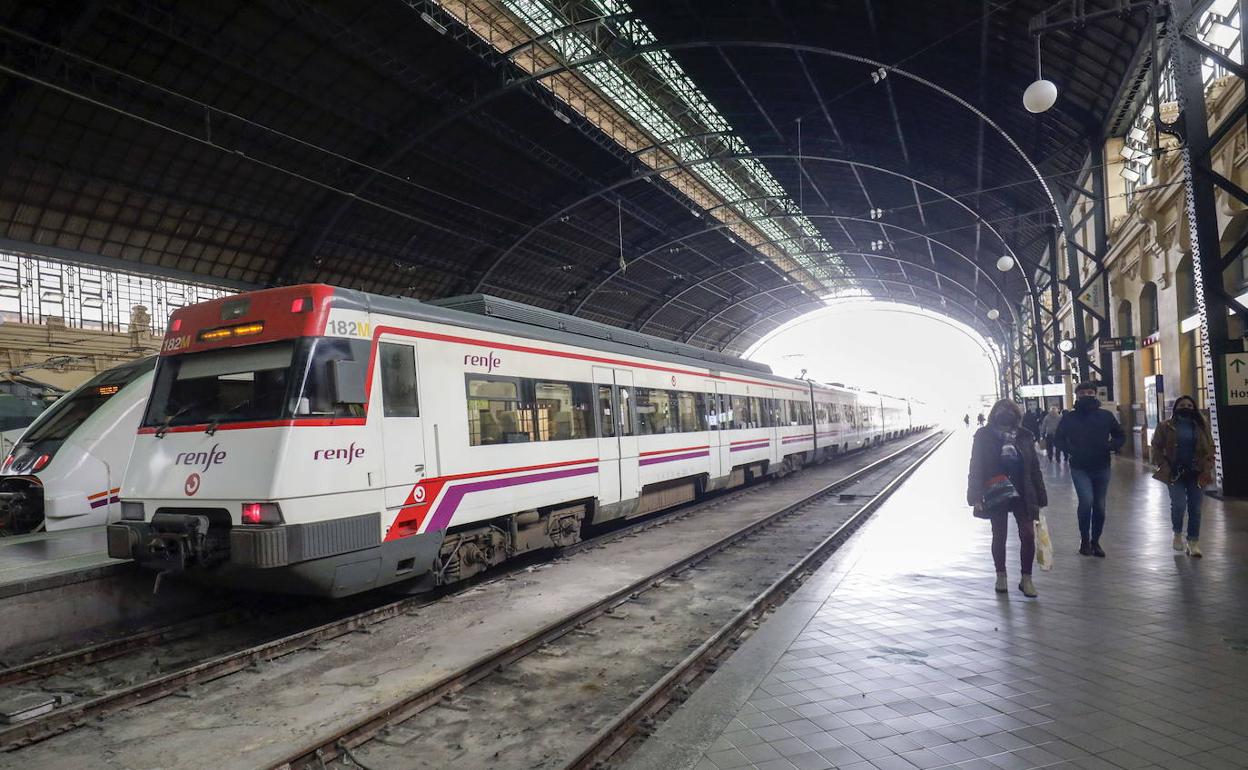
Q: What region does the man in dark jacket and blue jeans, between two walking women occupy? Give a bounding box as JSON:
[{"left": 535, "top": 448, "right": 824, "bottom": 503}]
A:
[{"left": 1056, "top": 382, "right": 1127, "bottom": 557}]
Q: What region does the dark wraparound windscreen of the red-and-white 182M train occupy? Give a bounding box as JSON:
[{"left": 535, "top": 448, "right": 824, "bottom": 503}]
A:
[{"left": 144, "top": 337, "right": 368, "bottom": 427}]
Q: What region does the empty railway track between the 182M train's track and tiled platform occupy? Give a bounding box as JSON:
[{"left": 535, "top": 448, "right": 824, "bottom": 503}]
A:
[{"left": 272, "top": 434, "right": 948, "bottom": 770}]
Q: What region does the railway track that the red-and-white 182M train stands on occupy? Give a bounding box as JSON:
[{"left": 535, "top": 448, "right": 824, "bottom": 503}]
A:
[{"left": 0, "top": 438, "right": 930, "bottom": 751}]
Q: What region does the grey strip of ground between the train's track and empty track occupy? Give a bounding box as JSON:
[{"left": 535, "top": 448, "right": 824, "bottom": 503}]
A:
[{"left": 0, "top": 434, "right": 938, "bottom": 770}]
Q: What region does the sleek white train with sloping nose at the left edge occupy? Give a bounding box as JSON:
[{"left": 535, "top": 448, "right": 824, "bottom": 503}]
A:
[{"left": 0, "top": 356, "right": 156, "bottom": 534}]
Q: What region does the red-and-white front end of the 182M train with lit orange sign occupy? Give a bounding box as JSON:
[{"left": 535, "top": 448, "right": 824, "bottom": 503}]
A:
[{"left": 109, "top": 286, "right": 381, "bottom": 594}]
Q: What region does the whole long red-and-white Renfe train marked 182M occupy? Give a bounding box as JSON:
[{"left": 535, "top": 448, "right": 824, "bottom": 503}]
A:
[{"left": 107, "top": 285, "right": 932, "bottom": 597}]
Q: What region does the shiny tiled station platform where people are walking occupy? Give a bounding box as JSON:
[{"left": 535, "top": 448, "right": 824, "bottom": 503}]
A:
[{"left": 625, "top": 431, "right": 1248, "bottom": 770}]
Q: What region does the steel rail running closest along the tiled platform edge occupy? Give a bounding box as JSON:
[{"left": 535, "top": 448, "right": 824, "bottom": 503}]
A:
[{"left": 564, "top": 432, "right": 952, "bottom": 770}]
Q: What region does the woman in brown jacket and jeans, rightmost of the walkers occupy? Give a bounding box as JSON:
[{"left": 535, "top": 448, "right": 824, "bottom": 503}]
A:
[{"left": 1152, "top": 396, "right": 1213, "bottom": 559}]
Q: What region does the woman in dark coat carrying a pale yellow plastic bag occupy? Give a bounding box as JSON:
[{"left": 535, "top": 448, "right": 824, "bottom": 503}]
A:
[{"left": 966, "top": 398, "right": 1048, "bottom": 598}]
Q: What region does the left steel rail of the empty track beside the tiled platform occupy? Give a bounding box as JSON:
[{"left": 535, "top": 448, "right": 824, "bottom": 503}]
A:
[{"left": 270, "top": 432, "right": 952, "bottom": 770}]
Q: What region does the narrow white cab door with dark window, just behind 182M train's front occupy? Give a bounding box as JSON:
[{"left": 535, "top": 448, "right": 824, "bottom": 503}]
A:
[{"left": 374, "top": 342, "right": 426, "bottom": 509}]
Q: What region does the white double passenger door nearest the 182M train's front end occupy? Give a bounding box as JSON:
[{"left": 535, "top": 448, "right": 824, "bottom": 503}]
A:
[{"left": 594, "top": 367, "right": 639, "bottom": 504}]
